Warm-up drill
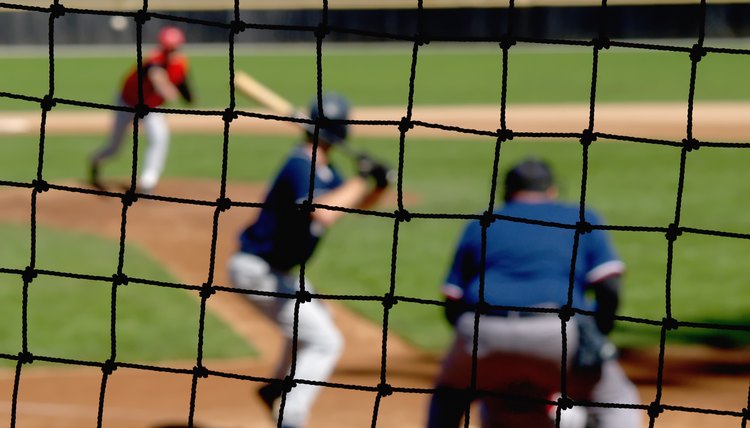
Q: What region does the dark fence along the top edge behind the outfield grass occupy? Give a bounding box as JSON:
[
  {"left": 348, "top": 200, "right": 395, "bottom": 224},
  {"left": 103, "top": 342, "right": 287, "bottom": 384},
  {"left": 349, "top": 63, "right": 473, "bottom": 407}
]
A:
[{"left": 0, "top": 4, "right": 750, "bottom": 45}]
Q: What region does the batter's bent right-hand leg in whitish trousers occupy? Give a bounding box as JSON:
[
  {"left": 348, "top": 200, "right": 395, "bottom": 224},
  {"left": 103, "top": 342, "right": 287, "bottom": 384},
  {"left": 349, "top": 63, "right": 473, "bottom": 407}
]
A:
[{"left": 277, "top": 275, "right": 344, "bottom": 427}]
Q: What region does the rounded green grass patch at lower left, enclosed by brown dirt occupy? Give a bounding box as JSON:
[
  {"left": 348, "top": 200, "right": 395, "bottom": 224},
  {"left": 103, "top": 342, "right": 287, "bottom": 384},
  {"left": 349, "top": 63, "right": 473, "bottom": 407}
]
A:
[{"left": 0, "top": 223, "right": 255, "bottom": 366}]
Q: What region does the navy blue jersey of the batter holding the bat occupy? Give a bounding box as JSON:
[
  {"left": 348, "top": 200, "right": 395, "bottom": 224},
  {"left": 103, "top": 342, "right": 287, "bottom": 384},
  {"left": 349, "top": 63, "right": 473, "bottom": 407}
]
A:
[{"left": 240, "top": 147, "right": 343, "bottom": 270}]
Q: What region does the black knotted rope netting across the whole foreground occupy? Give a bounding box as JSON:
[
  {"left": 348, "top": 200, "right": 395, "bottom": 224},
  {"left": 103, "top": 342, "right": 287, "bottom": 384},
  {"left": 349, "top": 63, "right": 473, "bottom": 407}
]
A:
[{"left": 0, "top": 0, "right": 750, "bottom": 427}]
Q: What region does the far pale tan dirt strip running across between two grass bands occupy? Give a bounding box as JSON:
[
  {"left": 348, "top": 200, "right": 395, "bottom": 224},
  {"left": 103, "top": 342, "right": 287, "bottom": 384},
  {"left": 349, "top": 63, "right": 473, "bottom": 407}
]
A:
[{"left": 0, "top": 102, "right": 750, "bottom": 141}]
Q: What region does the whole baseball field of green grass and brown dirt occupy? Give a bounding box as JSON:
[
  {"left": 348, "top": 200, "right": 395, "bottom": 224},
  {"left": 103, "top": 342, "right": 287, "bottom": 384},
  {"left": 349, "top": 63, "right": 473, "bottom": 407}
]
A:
[{"left": 0, "top": 42, "right": 750, "bottom": 428}]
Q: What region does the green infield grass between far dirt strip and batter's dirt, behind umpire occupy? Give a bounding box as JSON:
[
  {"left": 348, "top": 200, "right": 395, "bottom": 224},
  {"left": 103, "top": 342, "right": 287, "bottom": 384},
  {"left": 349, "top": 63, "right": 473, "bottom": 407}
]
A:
[{"left": 5, "top": 135, "right": 750, "bottom": 349}]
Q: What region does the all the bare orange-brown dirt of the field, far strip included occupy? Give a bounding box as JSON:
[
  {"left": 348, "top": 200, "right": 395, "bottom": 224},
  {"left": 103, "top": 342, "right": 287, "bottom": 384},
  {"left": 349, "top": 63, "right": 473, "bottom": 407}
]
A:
[{"left": 0, "top": 104, "right": 750, "bottom": 428}]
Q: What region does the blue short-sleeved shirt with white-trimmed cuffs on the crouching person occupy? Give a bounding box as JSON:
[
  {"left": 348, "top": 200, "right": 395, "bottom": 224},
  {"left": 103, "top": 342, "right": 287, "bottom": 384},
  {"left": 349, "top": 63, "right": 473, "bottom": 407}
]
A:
[{"left": 443, "top": 201, "right": 624, "bottom": 309}]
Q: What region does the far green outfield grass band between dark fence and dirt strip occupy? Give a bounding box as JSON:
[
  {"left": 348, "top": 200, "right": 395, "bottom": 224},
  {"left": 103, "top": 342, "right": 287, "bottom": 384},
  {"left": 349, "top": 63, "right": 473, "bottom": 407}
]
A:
[{"left": 0, "top": 43, "right": 750, "bottom": 110}]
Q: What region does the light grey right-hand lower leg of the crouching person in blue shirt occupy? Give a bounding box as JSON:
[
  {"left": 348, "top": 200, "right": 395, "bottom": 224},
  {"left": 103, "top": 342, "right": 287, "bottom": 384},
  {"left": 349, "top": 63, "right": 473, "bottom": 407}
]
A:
[{"left": 588, "top": 359, "right": 642, "bottom": 428}]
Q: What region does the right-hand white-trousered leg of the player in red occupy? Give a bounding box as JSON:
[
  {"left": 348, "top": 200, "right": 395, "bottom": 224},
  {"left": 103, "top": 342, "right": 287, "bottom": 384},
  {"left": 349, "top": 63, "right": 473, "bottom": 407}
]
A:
[{"left": 138, "top": 112, "right": 170, "bottom": 193}]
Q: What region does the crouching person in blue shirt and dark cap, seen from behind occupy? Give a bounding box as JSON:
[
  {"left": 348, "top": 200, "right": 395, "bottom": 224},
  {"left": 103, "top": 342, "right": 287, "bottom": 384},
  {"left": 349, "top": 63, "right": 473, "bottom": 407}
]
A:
[{"left": 428, "top": 158, "right": 639, "bottom": 428}]
